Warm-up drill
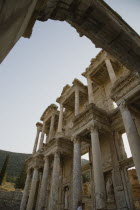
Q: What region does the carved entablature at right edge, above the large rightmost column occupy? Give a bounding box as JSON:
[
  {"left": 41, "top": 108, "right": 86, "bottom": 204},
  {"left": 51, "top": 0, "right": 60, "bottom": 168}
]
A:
[{"left": 110, "top": 72, "right": 140, "bottom": 104}]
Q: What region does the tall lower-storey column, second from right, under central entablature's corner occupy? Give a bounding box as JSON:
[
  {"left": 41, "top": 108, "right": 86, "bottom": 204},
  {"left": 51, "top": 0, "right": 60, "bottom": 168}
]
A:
[{"left": 90, "top": 126, "right": 106, "bottom": 209}]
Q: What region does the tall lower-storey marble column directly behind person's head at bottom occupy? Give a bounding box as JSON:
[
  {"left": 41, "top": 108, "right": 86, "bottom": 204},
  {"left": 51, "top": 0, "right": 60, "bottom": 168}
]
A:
[{"left": 73, "top": 137, "right": 82, "bottom": 210}]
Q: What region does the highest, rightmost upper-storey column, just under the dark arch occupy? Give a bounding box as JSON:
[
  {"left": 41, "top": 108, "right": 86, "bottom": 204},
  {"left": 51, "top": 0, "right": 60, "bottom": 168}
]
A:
[{"left": 105, "top": 58, "right": 117, "bottom": 84}]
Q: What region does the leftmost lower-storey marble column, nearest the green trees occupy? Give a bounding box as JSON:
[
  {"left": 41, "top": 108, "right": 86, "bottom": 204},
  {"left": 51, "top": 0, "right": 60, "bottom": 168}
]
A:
[{"left": 20, "top": 170, "right": 32, "bottom": 210}]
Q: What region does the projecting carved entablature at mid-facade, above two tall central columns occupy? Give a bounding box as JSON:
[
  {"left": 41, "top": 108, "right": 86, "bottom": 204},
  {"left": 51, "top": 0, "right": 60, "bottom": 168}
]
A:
[{"left": 73, "top": 104, "right": 109, "bottom": 132}]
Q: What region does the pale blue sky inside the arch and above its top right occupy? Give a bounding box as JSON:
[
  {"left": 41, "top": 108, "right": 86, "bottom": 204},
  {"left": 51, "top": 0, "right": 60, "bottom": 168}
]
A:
[{"left": 0, "top": 0, "right": 140, "bottom": 153}]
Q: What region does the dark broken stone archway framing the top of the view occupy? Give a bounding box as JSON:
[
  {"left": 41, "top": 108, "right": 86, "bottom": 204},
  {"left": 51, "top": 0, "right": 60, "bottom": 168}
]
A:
[{"left": 0, "top": 0, "right": 140, "bottom": 72}]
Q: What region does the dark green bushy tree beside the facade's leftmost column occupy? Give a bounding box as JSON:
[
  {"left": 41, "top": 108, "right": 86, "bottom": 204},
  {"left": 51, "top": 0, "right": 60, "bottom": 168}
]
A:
[{"left": 15, "top": 163, "right": 26, "bottom": 189}]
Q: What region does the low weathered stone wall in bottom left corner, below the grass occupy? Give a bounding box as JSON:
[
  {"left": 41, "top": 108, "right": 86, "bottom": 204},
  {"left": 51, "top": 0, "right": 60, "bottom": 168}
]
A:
[{"left": 0, "top": 191, "right": 22, "bottom": 210}]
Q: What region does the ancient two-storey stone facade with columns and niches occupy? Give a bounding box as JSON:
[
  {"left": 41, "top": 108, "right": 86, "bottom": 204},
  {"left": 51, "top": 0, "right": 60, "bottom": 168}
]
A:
[{"left": 20, "top": 51, "right": 140, "bottom": 210}]
